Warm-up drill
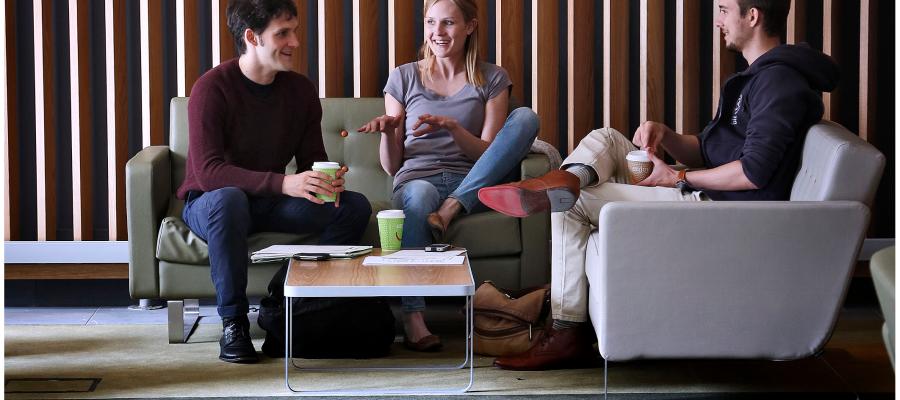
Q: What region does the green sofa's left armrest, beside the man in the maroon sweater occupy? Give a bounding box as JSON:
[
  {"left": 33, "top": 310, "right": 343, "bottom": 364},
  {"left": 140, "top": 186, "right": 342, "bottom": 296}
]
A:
[{"left": 125, "top": 146, "right": 172, "bottom": 299}]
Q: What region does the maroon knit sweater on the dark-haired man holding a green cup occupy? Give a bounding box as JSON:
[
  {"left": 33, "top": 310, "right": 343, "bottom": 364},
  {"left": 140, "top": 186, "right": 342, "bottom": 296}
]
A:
[{"left": 177, "top": 58, "right": 328, "bottom": 199}]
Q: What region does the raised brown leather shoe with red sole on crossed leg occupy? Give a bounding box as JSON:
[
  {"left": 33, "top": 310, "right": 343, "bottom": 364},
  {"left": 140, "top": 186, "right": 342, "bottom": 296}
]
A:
[{"left": 478, "top": 170, "right": 581, "bottom": 218}]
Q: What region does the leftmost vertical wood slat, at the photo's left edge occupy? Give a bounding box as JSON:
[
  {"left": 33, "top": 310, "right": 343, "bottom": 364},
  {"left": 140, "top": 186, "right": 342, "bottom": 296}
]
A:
[{"left": 0, "top": 0, "right": 21, "bottom": 240}]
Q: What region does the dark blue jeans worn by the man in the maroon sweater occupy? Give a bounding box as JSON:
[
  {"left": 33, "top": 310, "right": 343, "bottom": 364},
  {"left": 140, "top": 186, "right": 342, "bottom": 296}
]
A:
[{"left": 182, "top": 187, "right": 372, "bottom": 317}]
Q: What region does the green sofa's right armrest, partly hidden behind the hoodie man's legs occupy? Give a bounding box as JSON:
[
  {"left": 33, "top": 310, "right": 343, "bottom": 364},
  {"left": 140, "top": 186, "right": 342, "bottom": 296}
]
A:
[{"left": 519, "top": 153, "right": 550, "bottom": 288}]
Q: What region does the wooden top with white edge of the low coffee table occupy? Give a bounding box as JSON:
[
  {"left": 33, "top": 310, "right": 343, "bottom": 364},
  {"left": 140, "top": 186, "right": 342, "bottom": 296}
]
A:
[{"left": 284, "top": 249, "right": 475, "bottom": 297}]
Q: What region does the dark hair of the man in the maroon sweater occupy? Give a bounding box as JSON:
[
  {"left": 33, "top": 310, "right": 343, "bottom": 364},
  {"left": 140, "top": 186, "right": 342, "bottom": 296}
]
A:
[{"left": 226, "top": 0, "right": 297, "bottom": 54}]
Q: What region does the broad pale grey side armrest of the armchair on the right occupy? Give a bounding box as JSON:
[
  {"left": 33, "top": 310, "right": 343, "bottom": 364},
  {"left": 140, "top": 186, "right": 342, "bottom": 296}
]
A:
[{"left": 586, "top": 201, "right": 869, "bottom": 361}]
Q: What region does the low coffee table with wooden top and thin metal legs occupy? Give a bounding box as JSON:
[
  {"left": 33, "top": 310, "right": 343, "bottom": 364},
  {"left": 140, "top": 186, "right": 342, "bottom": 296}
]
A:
[{"left": 284, "top": 249, "right": 475, "bottom": 395}]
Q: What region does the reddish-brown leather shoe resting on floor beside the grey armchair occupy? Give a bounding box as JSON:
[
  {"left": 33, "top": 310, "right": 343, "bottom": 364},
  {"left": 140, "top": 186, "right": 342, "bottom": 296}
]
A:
[{"left": 494, "top": 324, "right": 597, "bottom": 371}]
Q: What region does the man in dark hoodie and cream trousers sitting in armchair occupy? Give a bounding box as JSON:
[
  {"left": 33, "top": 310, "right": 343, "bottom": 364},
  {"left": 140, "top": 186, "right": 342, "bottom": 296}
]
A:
[{"left": 479, "top": 0, "right": 838, "bottom": 370}]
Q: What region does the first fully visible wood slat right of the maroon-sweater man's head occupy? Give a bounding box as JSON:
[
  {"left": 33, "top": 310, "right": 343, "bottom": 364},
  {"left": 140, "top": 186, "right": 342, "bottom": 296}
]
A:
[{"left": 319, "top": 0, "right": 344, "bottom": 97}]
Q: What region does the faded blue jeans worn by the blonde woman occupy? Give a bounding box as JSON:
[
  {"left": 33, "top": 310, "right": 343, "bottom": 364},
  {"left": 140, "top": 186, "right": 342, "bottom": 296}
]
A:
[{"left": 393, "top": 107, "right": 540, "bottom": 312}]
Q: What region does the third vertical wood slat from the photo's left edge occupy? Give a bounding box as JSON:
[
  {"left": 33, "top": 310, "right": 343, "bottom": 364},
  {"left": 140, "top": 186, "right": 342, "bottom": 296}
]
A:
[{"left": 69, "top": 0, "right": 94, "bottom": 240}]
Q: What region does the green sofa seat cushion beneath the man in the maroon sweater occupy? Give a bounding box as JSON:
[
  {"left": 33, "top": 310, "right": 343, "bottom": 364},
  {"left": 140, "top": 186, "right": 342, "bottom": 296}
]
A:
[{"left": 156, "top": 216, "right": 316, "bottom": 265}]
